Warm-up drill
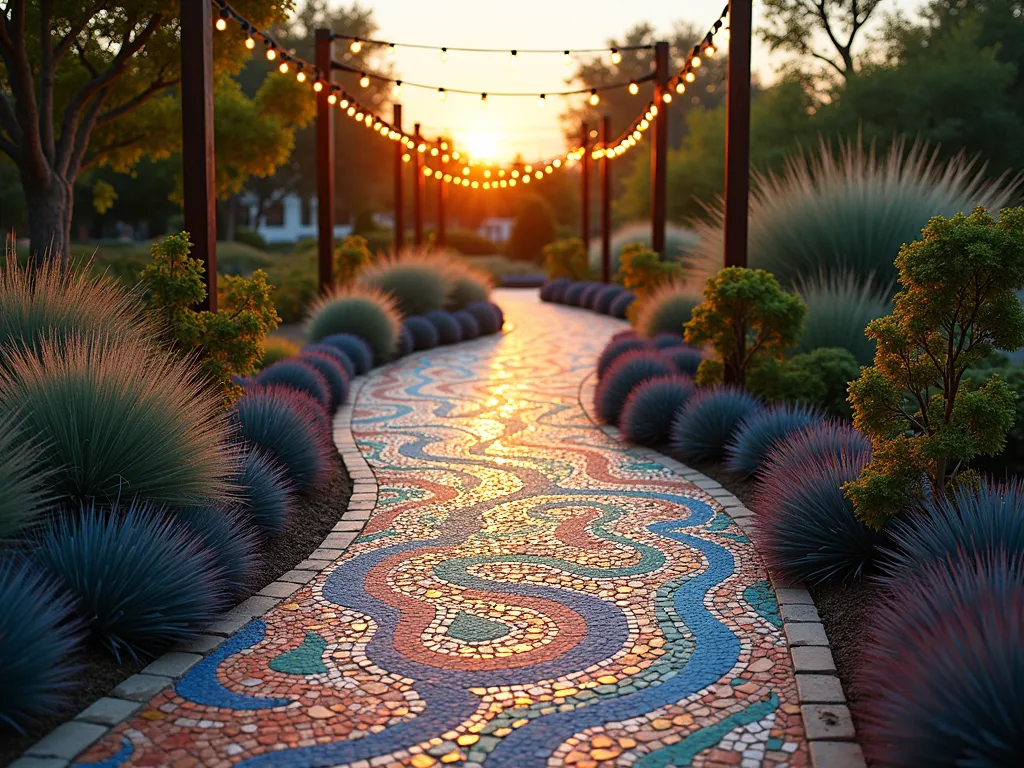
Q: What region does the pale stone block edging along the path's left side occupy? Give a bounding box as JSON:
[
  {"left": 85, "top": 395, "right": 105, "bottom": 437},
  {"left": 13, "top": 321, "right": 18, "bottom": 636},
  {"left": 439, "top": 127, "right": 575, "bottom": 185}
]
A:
[{"left": 10, "top": 376, "right": 377, "bottom": 768}]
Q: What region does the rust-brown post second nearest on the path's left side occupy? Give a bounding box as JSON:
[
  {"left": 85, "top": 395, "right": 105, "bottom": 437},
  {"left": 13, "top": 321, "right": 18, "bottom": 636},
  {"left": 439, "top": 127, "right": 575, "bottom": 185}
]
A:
[{"left": 315, "top": 29, "right": 334, "bottom": 294}]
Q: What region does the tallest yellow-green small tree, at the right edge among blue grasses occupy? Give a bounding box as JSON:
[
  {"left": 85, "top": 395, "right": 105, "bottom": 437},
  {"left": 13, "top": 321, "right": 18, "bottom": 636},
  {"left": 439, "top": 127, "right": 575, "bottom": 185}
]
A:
[{"left": 844, "top": 208, "right": 1024, "bottom": 527}]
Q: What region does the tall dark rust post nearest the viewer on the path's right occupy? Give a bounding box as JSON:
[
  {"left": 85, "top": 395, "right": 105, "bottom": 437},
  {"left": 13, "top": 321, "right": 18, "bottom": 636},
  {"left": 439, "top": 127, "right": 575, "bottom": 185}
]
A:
[{"left": 725, "top": 0, "right": 751, "bottom": 266}]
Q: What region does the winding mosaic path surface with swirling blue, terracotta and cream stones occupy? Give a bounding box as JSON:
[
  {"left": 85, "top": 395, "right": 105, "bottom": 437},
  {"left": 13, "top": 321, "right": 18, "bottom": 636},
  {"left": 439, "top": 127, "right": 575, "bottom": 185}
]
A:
[{"left": 75, "top": 293, "right": 808, "bottom": 768}]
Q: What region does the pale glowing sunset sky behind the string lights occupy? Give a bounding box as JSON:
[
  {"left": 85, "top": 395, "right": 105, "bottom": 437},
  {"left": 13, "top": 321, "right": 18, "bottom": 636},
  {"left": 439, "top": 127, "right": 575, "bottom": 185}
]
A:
[{"left": 332, "top": 0, "right": 839, "bottom": 162}]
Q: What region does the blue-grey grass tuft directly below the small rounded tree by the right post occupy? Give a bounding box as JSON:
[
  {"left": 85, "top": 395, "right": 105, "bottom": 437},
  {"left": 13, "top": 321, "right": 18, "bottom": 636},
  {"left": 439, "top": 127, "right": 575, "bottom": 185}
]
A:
[{"left": 669, "top": 386, "right": 762, "bottom": 462}]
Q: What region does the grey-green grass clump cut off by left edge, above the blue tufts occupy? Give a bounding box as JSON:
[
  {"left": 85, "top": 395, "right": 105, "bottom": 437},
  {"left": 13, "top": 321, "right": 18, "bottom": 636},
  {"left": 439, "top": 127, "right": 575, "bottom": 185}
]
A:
[{"left": 0, "top": 414, "right": 53, "bottom": 542}]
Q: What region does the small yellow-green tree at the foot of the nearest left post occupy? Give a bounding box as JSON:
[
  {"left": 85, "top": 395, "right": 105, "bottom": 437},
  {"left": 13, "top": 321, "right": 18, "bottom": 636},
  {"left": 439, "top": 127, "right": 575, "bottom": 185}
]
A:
[{"left": 141, "top": 232, "right": 281, "bottom": 403}]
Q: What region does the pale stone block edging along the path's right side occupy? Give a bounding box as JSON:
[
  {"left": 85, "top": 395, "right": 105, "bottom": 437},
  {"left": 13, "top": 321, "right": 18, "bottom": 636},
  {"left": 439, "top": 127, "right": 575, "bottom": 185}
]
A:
[{"left": 579, "top": 371, "right": 866, "bottom": 768}]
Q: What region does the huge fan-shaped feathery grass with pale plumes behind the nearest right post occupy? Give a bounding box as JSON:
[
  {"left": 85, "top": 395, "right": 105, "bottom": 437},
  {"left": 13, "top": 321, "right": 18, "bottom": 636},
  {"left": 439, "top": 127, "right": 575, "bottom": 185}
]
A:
[{"left": 693, "top": 139, "right": 1020, "bottom": 288}]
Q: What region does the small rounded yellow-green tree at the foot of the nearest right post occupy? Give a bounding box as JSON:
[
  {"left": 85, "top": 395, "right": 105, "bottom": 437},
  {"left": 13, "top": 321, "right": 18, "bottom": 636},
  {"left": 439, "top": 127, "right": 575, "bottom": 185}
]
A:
[{"left": 683, "top": 266, "right": 807, "bottom": 386}]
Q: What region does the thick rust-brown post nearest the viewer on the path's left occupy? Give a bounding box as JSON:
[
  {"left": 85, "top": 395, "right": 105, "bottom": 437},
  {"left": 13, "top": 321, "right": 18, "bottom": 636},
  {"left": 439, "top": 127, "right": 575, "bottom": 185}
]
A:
[{"left": 181, "top": 0, "right": 217, "bottom": 311}]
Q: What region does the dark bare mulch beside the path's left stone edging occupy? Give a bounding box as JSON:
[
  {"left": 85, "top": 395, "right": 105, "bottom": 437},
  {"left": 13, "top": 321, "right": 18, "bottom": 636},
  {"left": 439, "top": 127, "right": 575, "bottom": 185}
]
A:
[{"left": 0, "top": 455, "right": 352, "bottom": 766}]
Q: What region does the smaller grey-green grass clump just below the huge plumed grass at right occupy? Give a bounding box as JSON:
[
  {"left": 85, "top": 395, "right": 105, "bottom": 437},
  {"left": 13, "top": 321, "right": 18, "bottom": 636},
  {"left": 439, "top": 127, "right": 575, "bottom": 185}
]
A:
[{"left": 796, "top": 272, "right": 892, "bottom": 366}]
